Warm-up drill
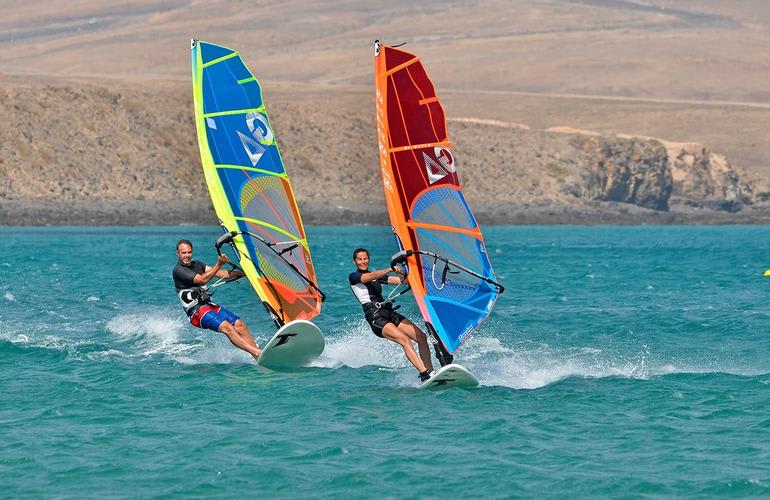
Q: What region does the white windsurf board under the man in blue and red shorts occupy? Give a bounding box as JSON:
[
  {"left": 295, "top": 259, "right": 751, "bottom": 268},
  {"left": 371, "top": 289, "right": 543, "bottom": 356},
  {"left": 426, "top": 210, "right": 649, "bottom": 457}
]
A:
[{"left": 257, "top": 319, "right": 324, "bottom": 370}]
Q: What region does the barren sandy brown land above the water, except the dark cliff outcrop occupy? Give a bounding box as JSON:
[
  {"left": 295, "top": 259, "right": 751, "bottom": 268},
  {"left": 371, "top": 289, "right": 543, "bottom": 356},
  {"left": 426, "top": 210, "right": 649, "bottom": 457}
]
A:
[{"left": 0, "top": 0, "right": 770, "bottom": 224}]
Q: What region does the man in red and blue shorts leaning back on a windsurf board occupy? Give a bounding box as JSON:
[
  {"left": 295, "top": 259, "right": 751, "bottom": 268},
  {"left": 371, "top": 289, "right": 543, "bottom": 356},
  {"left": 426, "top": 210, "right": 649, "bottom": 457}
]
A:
[{"left": 172, "top": 240, "right": 262, "bottom": 359}]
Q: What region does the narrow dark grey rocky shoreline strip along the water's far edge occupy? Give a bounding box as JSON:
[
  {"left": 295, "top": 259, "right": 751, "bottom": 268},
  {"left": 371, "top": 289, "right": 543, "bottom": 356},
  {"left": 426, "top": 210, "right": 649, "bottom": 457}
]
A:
[{"left": 0, "top": 200, "right": 770, "bottom": 227}]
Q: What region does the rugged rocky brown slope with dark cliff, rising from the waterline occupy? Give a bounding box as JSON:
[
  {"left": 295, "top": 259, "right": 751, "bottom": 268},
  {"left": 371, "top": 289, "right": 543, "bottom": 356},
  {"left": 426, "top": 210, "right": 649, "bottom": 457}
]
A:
[{"left": 0, "top": 81, "right": 768, "bottom": 224}]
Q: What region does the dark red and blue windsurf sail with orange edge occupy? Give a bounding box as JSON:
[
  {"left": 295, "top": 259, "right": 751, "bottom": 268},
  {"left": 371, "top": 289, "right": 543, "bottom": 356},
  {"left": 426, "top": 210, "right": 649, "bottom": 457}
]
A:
[{"left": 375, "top": 45, "right": 502, "bottom": 353}]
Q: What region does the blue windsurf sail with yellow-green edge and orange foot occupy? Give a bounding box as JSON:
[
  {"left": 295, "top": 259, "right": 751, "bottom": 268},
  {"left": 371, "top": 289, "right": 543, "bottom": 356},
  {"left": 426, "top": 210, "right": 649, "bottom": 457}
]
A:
[{"left": 191, "top": 41, "right": 322, "bottom": 323}]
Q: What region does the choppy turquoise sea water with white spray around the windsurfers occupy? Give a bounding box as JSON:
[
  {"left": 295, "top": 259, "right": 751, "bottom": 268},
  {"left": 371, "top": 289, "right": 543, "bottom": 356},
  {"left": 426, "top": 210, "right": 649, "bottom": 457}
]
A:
[{"left": 0, "top": 227, "right": 770, "bottom": 498}]
